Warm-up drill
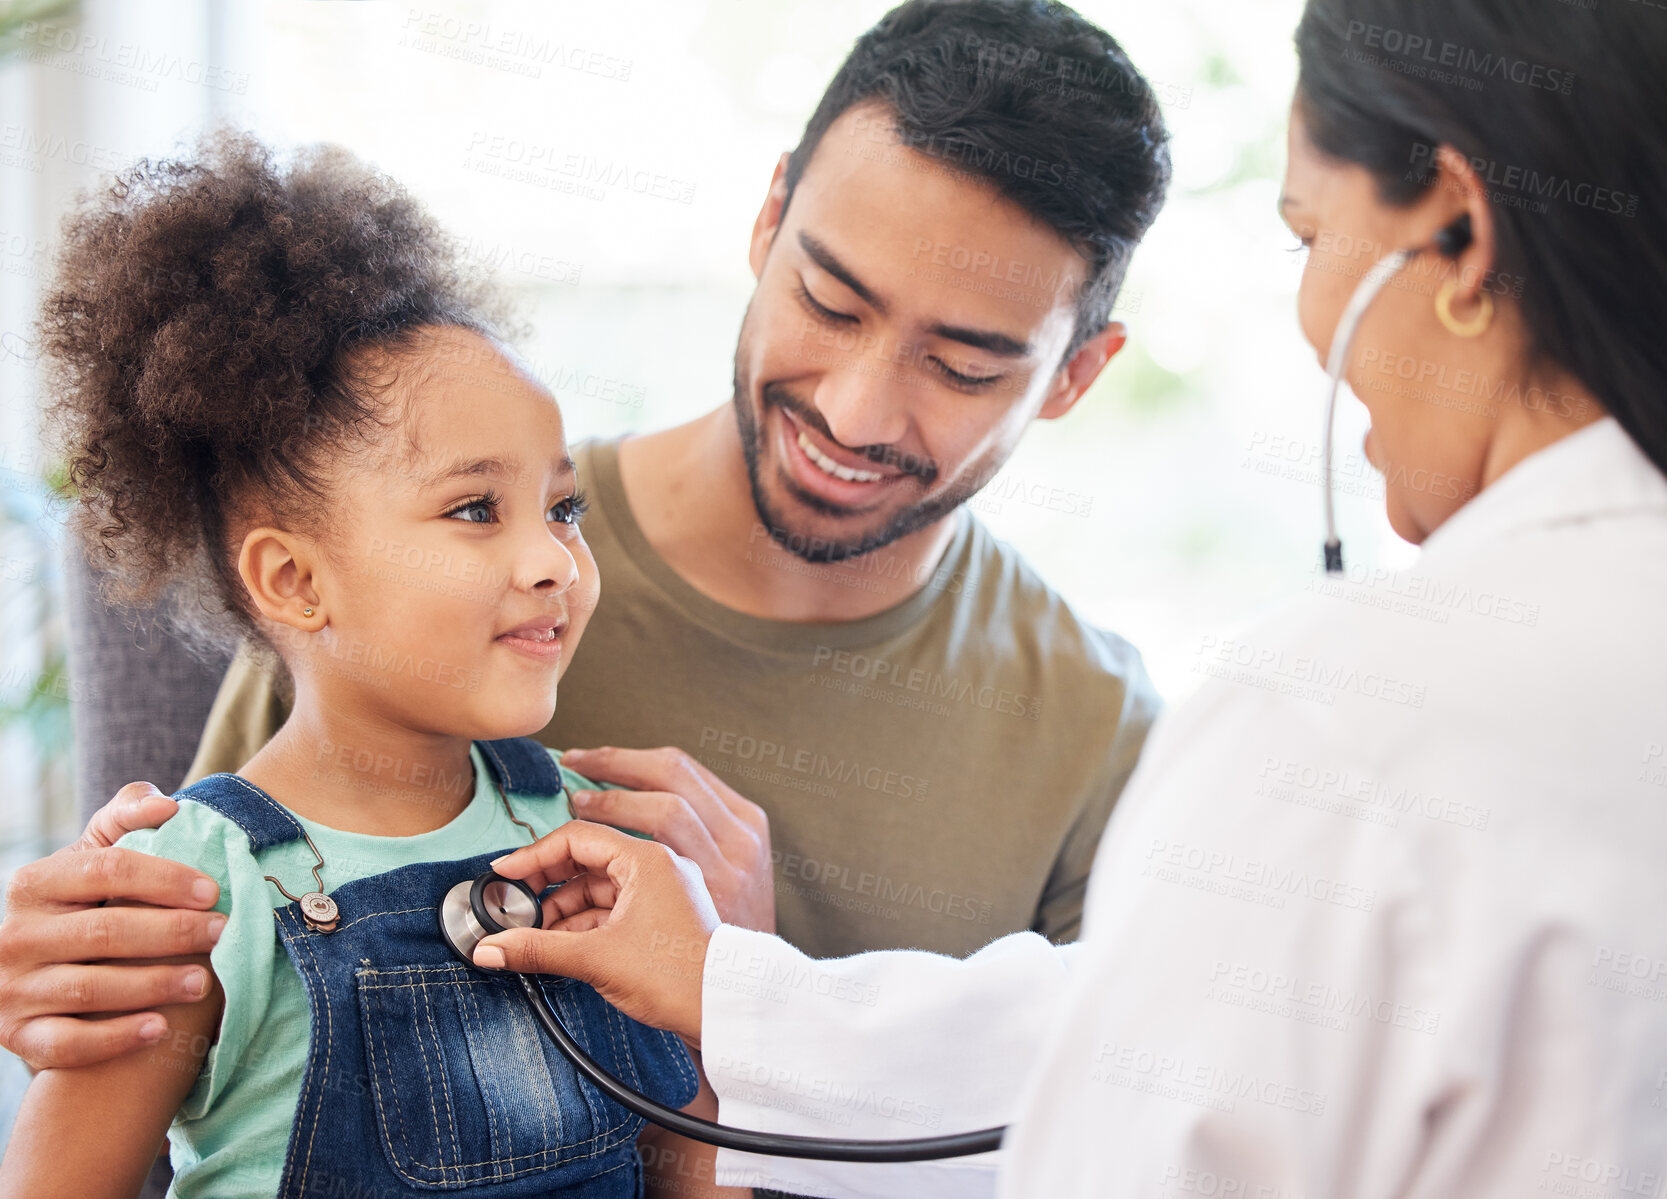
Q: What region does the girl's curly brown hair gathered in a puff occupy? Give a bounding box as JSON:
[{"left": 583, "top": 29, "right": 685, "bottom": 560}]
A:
[{"left": 40, "top": 130, "right": 500, "bottom": 642}]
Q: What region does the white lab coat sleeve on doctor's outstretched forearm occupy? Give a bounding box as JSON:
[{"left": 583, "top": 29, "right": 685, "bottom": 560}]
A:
[{"left": 702, "top": 926, "right": 1077, "bottom": 1199}]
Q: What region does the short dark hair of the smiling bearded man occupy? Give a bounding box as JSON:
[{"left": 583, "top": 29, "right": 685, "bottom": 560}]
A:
[{"left": 785, "top": 0, "right": 1170, "bottom": 359}]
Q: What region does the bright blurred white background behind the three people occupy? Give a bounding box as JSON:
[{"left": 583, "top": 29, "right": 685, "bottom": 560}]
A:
[{"left": 0, "top": 0, "right": 1410, "bottom": 1139}]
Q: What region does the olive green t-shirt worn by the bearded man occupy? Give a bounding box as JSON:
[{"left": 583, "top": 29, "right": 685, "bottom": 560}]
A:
[{"left": 190, "top": 442, "right": 1157, "bottom": 957}]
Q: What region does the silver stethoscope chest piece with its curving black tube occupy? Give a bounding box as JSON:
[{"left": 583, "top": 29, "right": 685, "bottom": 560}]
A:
[{"left": 440, "top": 870, "right": 1007, "bottom": 1162}]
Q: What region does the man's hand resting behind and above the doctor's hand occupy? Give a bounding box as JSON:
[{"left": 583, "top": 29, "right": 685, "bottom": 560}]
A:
[{"left": 562, "top": 745, "right": 775, "bottom": 932}]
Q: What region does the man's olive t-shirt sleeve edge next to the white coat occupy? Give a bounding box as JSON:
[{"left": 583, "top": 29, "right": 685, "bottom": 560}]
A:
[{"left": 1030, "top": 647, "right": 1162, "bottom": 944}]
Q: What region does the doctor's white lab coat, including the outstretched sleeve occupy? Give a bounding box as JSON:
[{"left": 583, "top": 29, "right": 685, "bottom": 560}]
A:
[{"left": 703, "top": 419, "right": 1667, "bottom": 1199}]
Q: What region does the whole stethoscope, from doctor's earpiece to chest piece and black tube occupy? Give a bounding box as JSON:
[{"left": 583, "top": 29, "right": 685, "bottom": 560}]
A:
[{"left": 423, "top": 215, "right": 1470, "bottom": 1162}]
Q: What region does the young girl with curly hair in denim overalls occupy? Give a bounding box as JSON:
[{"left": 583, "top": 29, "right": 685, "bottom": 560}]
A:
[{"left": 0, "top": 135, "right": 743, "bottom": 1199}]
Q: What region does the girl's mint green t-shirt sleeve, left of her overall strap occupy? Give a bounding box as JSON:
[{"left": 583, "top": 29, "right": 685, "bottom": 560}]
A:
[{"left": 117, "top": 800, "right": 277, "bottom": 1119}]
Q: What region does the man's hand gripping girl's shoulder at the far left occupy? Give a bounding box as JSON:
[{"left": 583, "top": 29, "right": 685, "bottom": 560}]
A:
[{"left": 0, "top": 782, "right": 225, "bottom": 1071}]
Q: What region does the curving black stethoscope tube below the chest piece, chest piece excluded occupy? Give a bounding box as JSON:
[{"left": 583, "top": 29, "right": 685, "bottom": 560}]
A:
[{"left": 515, "top": 974, "right": 1007, "bottom": 1162}]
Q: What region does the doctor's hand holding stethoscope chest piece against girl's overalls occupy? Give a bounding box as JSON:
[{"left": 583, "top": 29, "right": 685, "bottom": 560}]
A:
[{"left": 475, "top": 820, "right": 718, "bottom": 1047}]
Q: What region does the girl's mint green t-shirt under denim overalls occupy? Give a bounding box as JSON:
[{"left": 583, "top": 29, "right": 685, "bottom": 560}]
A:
[{"left": 118, "top": 747, "right": 600, "bottom": 1199}]
